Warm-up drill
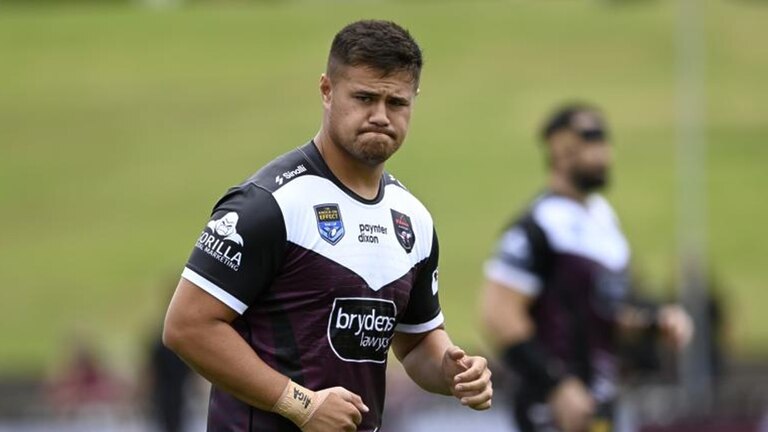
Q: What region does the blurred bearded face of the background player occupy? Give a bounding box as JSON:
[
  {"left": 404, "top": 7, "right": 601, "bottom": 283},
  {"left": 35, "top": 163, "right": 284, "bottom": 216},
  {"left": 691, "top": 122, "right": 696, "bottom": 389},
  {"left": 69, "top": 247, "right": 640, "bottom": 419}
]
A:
[{"left": 558, "top": 112, "right": 612, "bottom": 193}]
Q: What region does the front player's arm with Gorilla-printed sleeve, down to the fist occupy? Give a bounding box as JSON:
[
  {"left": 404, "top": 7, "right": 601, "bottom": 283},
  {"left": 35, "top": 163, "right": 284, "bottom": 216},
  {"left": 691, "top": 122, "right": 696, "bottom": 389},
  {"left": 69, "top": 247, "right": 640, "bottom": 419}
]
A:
[{"left": 163, "top": 186, "right": 367, "bottom": 432}]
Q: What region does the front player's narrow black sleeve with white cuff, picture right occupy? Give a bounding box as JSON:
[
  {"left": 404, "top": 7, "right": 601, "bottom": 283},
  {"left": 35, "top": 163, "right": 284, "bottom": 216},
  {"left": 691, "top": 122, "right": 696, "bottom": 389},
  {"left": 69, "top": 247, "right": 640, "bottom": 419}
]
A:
[{"left": 395, "top": 231, "right": 444, "bottom": 333}]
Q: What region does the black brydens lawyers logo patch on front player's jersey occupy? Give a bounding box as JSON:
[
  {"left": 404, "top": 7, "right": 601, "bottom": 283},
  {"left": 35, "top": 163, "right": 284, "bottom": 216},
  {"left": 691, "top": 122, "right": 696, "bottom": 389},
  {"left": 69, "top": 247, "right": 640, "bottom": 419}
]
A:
[{"left": 328, "top": 297, "right": 397, "bottom": 363}]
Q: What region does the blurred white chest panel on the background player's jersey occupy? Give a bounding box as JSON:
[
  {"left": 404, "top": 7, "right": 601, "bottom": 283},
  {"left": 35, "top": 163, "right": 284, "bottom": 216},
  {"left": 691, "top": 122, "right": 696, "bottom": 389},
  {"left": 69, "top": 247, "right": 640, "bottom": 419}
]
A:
[{"left": 533, "top": 195, "right": 630, "bottom": 271}]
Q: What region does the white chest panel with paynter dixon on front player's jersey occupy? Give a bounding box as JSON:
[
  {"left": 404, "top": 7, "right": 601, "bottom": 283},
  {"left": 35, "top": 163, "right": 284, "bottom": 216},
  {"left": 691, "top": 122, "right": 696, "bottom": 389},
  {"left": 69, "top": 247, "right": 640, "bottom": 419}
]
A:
[{"left": 274, "top": 175, "right": 433, "bottom": 291}]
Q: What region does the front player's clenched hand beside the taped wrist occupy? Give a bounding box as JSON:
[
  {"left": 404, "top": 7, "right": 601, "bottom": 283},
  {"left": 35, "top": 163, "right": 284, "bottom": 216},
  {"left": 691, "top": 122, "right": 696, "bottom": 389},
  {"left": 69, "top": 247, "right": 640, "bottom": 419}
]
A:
[{"left": 301, "top": 387, "right": 369, "bottom": 432}]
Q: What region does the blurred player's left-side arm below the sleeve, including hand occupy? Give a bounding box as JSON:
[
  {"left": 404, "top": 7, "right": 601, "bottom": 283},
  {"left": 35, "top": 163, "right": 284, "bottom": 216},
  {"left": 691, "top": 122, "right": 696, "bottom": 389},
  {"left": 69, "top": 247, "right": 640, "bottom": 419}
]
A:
[{"left": 482, "top": 279, "right": 595, "bottom": 431}]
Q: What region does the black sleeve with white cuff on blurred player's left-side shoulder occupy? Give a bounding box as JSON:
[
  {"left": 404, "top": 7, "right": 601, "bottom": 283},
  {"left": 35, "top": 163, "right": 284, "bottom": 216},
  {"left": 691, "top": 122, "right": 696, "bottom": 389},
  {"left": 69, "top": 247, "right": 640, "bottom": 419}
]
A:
[{"left": 485, "top": 221, "right": 548, "bottom": 296}]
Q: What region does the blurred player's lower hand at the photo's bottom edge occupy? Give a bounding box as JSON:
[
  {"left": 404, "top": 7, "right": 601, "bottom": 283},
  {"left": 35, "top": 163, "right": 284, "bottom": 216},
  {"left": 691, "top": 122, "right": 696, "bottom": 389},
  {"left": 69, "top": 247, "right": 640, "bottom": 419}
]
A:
[{"left": 549, "top": 377, "right": 596, "bottom": 432}]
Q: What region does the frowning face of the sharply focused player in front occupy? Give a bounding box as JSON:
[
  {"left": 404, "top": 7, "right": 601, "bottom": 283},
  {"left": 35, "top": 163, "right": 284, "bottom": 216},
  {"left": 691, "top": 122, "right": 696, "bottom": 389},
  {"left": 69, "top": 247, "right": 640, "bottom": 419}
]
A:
[{"left": 320, "top": 66, "right": 417, "bottom": 166}]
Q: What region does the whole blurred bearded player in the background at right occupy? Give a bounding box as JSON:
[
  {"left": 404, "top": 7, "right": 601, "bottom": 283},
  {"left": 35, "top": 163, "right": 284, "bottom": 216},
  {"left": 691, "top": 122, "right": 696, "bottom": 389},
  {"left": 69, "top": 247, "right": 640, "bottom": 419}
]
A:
[{"left": 483, "top": 104, "right": 692, "bottom": 432}]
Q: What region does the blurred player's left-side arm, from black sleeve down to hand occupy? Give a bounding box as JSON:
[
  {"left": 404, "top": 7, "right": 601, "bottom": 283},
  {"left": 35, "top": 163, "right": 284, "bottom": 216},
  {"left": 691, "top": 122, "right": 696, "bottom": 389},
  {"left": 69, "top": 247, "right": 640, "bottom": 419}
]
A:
[{"left": 482, "top": 225, "right": 595, "bottom": 432}]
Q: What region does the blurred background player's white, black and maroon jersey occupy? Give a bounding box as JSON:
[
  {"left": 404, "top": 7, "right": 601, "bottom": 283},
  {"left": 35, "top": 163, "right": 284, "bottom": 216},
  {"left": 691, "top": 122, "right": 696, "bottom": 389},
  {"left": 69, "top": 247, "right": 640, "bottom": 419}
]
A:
[{"left": 485, "top": 193, "right": 630, "bottom": 430}]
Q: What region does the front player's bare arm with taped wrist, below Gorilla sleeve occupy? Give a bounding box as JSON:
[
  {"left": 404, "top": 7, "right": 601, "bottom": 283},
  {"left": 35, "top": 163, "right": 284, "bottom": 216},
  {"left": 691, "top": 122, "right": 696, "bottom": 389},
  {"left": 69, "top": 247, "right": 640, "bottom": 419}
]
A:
[{"left": 163, "top": 278, "right": 368, "bottom": 431}]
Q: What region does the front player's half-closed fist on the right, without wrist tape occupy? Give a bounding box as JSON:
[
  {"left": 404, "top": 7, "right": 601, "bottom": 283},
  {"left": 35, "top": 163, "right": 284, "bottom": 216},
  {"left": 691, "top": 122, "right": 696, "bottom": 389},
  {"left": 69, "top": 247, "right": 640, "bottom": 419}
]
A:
[{"left": 442, "top": 346, "right": 493, "bottom": 410}]
